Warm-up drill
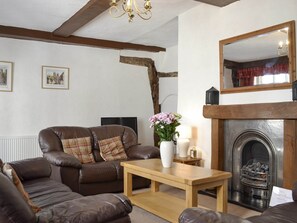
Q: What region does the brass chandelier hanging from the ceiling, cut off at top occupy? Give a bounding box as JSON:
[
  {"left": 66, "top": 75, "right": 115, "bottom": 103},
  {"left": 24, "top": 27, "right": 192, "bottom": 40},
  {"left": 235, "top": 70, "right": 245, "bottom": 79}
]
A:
[{"left": 109, "top": 0, "right": 152, "bottom": 22}]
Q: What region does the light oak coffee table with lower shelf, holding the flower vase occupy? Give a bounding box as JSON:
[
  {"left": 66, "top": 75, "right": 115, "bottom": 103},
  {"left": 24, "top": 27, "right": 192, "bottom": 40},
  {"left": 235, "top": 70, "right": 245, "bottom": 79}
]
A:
[{"left": 121, "top": 159, "right": 231, "bottom": 222}]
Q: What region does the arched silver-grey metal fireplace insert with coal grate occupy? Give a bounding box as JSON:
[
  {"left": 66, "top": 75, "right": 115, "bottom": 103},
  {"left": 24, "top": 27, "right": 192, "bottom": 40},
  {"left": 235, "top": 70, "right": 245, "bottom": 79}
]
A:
[{"left": 224, "top": 120, "right": 284, "bottom": 210}]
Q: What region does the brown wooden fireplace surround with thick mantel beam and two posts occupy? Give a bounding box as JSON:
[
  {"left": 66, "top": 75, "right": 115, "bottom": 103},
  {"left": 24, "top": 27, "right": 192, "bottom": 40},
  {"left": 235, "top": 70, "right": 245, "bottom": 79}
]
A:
[{"left": 203, "top": 102, "right": 297, "bottom": 189}]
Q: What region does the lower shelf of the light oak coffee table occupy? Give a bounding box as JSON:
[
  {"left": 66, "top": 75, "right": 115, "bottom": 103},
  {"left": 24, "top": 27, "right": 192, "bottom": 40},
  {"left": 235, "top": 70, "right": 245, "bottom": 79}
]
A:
[{"left": 128, "top": 191, "right": 186, "bottom": 222}]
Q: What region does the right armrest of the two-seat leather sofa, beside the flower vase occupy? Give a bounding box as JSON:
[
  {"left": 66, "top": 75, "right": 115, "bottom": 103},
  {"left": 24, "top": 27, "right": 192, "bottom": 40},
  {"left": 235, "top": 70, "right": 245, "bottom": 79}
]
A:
[{"left": 126, "top": 145, "right": 160, "bottom": 159}]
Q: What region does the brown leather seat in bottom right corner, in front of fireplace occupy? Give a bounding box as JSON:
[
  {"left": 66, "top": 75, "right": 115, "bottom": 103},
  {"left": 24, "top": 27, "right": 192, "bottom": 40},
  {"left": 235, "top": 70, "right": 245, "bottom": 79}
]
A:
[{"left": 179, "top": 183, "right": 297, "bottom": 223}]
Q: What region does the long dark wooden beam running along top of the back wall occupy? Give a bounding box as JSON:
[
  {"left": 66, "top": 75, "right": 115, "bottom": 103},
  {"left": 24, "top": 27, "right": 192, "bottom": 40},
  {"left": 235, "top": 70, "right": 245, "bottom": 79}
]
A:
[{"left": 0, "top": 25, "right": 166, "bottom": 52}]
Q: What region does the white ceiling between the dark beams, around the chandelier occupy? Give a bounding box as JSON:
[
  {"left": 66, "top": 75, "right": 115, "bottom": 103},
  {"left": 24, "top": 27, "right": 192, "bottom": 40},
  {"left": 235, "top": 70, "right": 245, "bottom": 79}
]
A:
[{"left": 0, "top": 0, "right": 200, "bottom": 48}]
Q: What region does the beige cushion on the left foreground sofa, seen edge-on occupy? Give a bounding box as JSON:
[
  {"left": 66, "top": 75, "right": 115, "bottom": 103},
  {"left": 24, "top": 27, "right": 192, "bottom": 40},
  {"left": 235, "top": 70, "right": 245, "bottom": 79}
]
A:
[{"left": 2, "top": 163, "right": 41, "bottom": 213}]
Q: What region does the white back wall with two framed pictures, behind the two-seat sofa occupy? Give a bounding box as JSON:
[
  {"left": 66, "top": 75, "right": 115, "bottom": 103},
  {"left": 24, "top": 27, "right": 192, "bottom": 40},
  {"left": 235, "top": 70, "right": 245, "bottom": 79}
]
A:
[{"left": 0, "top": 38, "right": 177, "bottom": 147}]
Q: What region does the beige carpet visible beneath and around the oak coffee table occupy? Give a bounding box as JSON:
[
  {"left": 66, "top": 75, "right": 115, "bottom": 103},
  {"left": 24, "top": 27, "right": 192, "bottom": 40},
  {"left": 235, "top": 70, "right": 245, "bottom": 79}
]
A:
[{"left": 130, "top": 185, "right": 260, "bottom": 223}]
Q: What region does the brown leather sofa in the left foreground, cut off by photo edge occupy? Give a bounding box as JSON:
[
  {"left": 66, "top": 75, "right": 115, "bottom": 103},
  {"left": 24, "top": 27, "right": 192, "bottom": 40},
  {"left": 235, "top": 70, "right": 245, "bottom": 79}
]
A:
[{"left": 0, "top": 157, "right": 132, "bottom": 223}]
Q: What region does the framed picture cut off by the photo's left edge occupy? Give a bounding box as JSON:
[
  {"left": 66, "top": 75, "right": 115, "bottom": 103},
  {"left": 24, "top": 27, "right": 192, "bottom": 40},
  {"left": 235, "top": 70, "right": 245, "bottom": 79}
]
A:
[{"left": 0, "top": 61, "right": 13, "bottom": 91}]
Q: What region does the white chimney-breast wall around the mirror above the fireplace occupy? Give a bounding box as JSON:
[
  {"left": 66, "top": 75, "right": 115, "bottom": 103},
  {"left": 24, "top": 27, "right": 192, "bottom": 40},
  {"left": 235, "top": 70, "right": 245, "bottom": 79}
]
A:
[{"left": 178, "top": 0, "right": 297, "bottom": 167}]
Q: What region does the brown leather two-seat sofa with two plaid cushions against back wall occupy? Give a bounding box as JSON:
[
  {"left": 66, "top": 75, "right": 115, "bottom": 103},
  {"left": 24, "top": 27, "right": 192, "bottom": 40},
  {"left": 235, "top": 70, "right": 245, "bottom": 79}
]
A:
[{"left": 39, "top": 125, "right": 160, "bottom": 195}]
